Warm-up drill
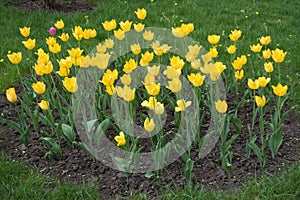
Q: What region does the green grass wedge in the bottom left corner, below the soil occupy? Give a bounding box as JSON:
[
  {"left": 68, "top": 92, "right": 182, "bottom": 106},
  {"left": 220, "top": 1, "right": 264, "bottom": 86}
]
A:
[{"left": 0, "top": 153, "right": 99, "bottom": 199}]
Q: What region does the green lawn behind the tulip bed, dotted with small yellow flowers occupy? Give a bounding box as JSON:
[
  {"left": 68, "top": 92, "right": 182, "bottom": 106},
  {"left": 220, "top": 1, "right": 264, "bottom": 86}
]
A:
[{"left": 0, "top": 0, "right": 300, "bottom": 104}]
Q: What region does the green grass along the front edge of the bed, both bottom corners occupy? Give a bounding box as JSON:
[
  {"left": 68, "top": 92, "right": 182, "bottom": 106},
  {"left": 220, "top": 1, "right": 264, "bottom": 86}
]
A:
[{"left": 0, "top": 154, "right": 300, "bottom": 200}]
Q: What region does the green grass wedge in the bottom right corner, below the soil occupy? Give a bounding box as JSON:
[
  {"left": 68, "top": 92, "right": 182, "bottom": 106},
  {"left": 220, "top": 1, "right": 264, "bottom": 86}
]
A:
[{"left": 162, "top": 164, "right": 300, "bottom": 200}]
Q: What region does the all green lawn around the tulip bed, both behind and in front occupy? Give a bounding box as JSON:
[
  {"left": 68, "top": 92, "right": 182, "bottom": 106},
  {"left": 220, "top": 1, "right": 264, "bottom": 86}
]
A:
[{"left": 0, "top": 0, "right": 300, "bottom": 199}]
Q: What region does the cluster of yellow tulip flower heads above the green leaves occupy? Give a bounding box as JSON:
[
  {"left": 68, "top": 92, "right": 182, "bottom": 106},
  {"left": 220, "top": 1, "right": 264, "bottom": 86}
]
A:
[{"left": 2, "top": 8, "right": 288, "bottom": 177}]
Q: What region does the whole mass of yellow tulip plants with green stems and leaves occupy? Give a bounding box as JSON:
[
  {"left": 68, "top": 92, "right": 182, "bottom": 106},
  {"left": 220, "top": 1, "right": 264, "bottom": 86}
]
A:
[{"left": 4, "top": 8, "right": 290, "bottom": 181}]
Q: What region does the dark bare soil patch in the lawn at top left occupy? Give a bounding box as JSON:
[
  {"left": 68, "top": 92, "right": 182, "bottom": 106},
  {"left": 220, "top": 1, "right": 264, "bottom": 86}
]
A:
[{"left": 6, "top": 0, "right": 97, "bottom": 13}]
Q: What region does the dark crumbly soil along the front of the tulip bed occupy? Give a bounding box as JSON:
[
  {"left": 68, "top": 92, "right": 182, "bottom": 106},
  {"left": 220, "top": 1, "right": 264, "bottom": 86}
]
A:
[{"left": 0, "top": 91, "right": 300, "bottom": 199}]
